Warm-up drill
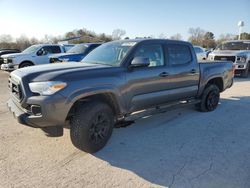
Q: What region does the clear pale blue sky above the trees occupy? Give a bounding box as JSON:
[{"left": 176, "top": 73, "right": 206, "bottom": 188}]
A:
[{"left": 0, "top": 0, "right": 250, "bottom": 40}]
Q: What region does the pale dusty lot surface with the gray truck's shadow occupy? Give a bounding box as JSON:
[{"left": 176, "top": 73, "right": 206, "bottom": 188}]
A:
[{"left": 0, "top": 71, "right": 250, "bottom": 188}]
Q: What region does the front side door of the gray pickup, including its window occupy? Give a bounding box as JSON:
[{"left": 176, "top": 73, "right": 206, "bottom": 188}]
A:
[{"left": 126, "top": 44, "right": 168, "bottom": 112}]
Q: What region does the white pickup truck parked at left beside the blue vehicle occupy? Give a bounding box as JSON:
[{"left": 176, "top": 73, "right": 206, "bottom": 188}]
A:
[{"left": 1, "top": 44, "right": 65, "bottom": 71}]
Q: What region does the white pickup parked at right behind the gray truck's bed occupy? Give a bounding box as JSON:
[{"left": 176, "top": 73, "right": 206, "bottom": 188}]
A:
[{"left": 208, "top": 40, "right": 250, "bottom": 78}]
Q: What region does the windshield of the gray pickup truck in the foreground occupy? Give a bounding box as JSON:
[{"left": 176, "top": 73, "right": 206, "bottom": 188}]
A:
[{"left": 82, "top": 41, "right": 136, "bottom": 66}]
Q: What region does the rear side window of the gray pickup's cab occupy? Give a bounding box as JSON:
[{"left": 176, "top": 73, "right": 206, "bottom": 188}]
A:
[{"left": 167, "top": 44, "right": 192, "bottom": 65}]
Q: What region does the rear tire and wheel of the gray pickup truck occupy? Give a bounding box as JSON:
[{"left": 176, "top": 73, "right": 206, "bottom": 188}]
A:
[{"left": 196, "top": 85, "right": 220, "bottom": 112}]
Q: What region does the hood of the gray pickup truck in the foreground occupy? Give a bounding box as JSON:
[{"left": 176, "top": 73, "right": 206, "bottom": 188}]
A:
[{"left": 11, "top": 62, "right": 110, "bottom": 82}]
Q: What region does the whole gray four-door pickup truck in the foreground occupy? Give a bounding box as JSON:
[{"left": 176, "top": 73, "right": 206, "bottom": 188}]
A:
[{"left": 7, "top": 39, "right": 234, "bottom": 153}]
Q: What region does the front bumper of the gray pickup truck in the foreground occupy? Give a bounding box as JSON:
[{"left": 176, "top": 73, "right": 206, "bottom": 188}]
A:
[{"left": 7, "top": 95, "right": 70, "bottom": 128}]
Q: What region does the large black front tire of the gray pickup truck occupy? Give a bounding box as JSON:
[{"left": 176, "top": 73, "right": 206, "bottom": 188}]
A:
[{"left": 70, "top": 101, "right": 115, "bottom": 153}]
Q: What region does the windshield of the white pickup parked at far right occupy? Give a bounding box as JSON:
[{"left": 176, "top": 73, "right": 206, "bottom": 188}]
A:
[{"left": 215, "top": 42, "right": 250, "bottom": 50}]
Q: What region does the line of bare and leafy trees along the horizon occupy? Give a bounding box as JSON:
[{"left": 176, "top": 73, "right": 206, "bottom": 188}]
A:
[{"left": 0, "top": 27, "right": 250, "bottom": 50}]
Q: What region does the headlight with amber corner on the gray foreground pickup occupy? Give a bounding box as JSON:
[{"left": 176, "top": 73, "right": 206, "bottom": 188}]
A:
[{"left": 29, "top": 81, "right": 67, "bottom": 95}]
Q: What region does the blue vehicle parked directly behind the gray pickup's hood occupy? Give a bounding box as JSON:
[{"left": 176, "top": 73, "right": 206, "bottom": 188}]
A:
[{"left": 50, "top": 43, "right": 101, "bottom": 63}]
